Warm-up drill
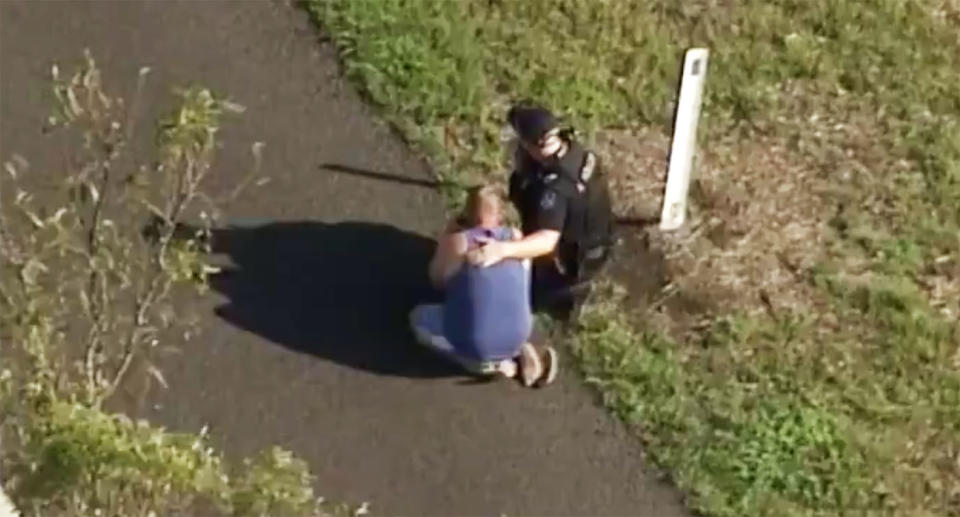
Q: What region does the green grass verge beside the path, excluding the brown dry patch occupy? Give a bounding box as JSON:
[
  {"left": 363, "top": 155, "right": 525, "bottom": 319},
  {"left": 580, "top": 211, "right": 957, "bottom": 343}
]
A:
[{"left": 306, "top": 0, "right": 960, "bottom": 516}]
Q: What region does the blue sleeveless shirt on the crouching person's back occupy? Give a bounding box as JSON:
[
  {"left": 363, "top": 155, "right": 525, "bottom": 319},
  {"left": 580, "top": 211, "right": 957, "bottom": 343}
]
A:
[{"left": 443, "top": 227, "right": 533, "bottom": 361}]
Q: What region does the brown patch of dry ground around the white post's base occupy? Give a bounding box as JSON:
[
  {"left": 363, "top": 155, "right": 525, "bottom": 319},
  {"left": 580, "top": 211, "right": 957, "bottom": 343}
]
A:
[{"left": 597, "top": 128, "right": 832, "bottom": 328}]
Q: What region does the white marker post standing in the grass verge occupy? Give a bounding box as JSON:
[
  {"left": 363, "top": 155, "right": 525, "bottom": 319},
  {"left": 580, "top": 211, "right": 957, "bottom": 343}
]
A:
[{"left": 660, "top": 48, "right": 710, "bottom": 231}]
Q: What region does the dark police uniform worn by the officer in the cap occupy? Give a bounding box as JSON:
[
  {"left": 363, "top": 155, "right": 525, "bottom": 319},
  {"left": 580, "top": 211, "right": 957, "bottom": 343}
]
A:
[{"left": 509, "top": 133, "right": 613, "bottom": 310}]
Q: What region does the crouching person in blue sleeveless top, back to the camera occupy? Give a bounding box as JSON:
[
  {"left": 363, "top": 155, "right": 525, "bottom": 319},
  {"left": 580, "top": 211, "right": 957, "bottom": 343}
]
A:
[{"left": 411, "top": 187, "right": 557, "bottom": 386}]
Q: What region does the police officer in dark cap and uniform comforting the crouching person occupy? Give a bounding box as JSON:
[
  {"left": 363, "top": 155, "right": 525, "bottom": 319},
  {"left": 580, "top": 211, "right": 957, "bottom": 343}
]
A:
[{"left": 468, "top": 105, "right": 613, "bottom": 318}]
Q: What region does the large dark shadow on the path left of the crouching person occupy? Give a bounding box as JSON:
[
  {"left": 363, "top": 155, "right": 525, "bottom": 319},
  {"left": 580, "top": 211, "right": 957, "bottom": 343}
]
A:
[{"left": 180, "top": 216, "right": 462, "bottom": 377}]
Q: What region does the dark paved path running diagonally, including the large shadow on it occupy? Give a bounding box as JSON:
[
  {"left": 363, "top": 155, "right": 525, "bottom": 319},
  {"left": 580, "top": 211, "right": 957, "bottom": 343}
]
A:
[{"left": 0, "top": 0, "right": 684, "bottom": 516}]
